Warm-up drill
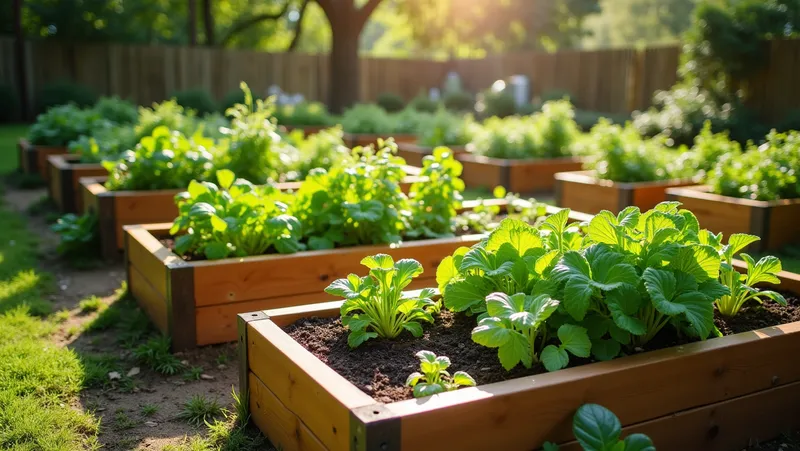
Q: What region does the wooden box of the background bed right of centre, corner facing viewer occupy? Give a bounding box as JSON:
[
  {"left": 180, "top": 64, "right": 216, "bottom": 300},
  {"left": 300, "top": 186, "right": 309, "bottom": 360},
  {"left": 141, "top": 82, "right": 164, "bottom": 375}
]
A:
[{"left": 456, "top": 153, "right": 583, "bottom": 193}]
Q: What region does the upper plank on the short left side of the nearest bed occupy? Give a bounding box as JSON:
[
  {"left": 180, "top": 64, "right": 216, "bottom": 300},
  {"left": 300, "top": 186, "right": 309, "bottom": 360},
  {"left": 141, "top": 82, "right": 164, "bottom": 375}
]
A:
[{"left": 247, "top": 320, "right": 375, "bottom": 451}]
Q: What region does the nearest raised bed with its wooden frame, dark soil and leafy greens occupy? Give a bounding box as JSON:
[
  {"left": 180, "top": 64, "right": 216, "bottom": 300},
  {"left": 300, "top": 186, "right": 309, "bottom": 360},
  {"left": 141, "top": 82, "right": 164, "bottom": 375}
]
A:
[{"left": 239, "top": 203, "right": 800, "bottom": 450}]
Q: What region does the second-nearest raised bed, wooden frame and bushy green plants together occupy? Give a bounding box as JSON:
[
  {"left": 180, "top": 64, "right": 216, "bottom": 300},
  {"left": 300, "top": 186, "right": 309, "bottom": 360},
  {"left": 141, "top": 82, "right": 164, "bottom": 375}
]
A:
[{"left": 125, "top": 150, "right": 587, "bottom": 349}]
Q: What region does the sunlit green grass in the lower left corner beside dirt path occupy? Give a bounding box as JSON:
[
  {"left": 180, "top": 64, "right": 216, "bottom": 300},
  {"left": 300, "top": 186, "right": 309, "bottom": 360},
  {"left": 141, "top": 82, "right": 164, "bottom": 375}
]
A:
[{"left": 0, "top": 202, "right": 99, "bottom": 451}]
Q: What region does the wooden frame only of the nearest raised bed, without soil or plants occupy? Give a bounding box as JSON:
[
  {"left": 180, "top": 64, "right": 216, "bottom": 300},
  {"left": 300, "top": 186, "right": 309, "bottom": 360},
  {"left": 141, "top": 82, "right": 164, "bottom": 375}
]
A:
[{"left": 239, "top": 273, "right": 800, "bottom": 451}]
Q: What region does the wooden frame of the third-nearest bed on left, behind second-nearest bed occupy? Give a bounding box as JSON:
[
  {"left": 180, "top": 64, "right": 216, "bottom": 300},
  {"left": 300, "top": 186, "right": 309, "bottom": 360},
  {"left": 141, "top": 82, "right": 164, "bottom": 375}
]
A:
[{"left": 80, "top": 172, "right": 421, "bottom": 260}]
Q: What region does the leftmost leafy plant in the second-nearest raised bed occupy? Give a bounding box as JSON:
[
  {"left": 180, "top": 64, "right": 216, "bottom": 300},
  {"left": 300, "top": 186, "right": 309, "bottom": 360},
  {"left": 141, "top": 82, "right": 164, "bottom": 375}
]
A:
[{"left": 170, "top": 170, "right": 305, "bottom": 260}]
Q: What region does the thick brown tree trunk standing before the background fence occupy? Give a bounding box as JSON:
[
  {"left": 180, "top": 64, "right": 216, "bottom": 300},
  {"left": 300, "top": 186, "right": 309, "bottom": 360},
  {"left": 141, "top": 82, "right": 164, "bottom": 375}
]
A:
[{"left": 329, "top": 22, "right": 364, "bottom": 114}]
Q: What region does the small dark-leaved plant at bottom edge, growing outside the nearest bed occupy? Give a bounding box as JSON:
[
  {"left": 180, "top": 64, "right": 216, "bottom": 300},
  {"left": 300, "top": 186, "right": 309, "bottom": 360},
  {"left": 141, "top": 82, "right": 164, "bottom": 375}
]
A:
[{"left": 544, "top": 404, "right": 656, "bottom": 451}]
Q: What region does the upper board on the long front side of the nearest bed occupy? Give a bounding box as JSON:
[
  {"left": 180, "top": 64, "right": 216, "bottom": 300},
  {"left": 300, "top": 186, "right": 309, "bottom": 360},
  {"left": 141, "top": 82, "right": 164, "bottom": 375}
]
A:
[{"left": 387, "top": 323, "right": 800, "bottom": 450}]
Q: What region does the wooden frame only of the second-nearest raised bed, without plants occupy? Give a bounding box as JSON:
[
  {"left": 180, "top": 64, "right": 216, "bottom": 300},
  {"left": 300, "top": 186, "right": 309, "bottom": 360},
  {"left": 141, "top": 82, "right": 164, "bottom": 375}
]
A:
[{"left": 124, "top": 202, "right": 588, "bottom": 349}]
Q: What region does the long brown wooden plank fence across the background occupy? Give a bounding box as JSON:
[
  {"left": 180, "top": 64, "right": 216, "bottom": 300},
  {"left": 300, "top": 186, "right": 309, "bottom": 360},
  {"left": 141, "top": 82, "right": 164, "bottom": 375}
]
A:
[{"left": 0, "top": 38, "right": 800, "bottom": 118}]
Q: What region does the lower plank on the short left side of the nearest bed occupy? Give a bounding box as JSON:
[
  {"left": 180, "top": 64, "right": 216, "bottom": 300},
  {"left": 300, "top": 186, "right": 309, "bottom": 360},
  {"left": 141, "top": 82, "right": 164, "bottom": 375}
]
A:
[{"left": 248, "top": 372, "right": 328, "bottom": 451}]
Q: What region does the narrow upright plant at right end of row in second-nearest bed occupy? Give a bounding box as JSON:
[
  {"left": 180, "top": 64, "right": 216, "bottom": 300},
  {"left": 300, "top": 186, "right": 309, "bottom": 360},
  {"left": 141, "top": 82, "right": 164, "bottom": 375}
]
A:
[{"left": 406, "top": 147, "right": 464, "bottom": 238}]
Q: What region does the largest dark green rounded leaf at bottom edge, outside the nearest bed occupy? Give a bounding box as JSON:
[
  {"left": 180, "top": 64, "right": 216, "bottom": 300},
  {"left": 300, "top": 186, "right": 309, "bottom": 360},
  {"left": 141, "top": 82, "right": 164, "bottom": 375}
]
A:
[{"left": 572, "top": 404, "right": 622, "bottom": 451}]
